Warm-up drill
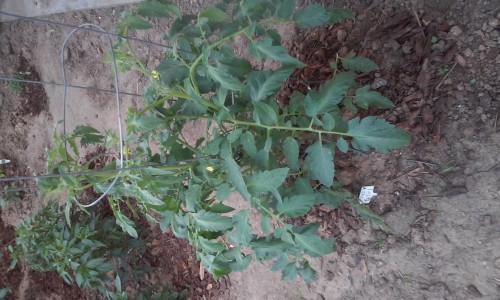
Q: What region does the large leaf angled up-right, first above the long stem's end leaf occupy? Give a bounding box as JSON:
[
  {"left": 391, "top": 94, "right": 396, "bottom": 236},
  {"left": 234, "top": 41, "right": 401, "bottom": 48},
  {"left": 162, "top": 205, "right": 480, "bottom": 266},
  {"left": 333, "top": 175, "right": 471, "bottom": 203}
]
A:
[{"left": 304, "top": 72, "right": 354, "bottom": 117}]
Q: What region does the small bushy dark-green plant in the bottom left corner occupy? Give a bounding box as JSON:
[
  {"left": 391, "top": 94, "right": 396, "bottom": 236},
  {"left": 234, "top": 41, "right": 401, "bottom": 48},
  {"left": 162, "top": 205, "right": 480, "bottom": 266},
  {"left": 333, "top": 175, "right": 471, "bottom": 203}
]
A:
[{"left": 9, "top": 202, "right": 143, "bottom": 292}]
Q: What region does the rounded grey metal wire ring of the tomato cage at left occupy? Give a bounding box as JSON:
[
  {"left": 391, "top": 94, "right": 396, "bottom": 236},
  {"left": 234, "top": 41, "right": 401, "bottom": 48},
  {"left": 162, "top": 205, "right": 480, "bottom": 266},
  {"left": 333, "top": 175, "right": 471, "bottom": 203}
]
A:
[{"left": 61, "top": 24, "right": 123, "bottom": 208}]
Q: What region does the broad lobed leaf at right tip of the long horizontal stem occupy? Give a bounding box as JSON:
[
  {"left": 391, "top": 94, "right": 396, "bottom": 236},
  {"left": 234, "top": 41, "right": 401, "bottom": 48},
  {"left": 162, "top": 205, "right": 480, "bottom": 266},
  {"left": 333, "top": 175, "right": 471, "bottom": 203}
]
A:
[{"left": 347, "top": 116, "right": 411, "bottom": 153}]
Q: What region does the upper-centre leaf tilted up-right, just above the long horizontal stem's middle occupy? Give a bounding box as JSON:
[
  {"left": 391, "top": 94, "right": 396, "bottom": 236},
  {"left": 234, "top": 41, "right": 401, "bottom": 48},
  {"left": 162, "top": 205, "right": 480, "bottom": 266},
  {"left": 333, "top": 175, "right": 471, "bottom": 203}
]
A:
[{"left": 248, "top": 68, "right": 293, "bottom": 101}]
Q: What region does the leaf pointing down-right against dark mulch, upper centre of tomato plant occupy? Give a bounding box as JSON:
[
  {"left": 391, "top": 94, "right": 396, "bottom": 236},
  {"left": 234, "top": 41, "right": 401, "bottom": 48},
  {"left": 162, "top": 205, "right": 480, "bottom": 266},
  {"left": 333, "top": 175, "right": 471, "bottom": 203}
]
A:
[{"left": 248, "top": 37, "right": 306, "bottom": 68}]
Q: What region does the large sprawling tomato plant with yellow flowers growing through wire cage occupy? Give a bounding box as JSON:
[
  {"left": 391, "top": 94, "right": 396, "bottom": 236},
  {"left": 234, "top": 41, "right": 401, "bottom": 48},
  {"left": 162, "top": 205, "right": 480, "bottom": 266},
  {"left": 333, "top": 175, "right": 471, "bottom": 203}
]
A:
[{"left": 38, "top": 0, "right": 410, "bottom": 281}]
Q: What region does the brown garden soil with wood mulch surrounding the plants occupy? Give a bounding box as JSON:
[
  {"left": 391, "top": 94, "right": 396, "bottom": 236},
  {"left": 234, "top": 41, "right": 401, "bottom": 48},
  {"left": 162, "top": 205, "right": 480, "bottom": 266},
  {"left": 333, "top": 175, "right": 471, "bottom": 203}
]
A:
[{"left": 0, "top": 0, "right": 500, "bottom": 300}]
